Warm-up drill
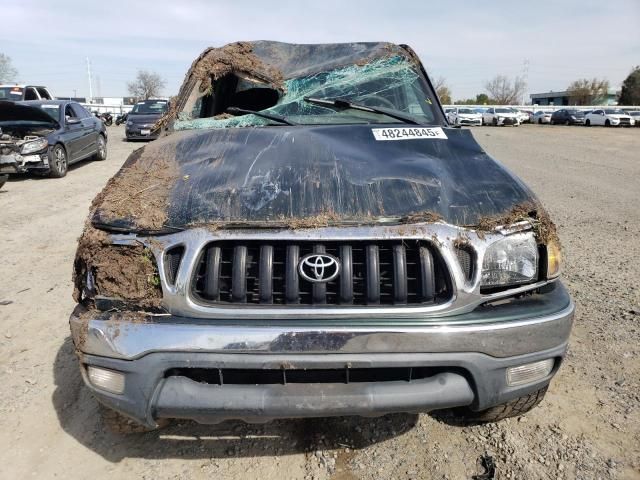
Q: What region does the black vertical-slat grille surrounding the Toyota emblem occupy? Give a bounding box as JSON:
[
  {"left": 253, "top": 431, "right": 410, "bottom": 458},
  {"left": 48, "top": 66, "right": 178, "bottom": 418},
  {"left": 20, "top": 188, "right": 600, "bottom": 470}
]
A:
[{"left": 192, "top": 240, "right": 452, "bottom": 308}]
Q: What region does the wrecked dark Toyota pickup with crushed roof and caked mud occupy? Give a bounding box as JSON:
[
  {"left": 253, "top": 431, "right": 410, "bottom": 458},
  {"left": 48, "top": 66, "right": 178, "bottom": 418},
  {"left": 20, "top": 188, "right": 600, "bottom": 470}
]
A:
[{"left": 70, "top": 41, "right": 574, "bottom": 430}]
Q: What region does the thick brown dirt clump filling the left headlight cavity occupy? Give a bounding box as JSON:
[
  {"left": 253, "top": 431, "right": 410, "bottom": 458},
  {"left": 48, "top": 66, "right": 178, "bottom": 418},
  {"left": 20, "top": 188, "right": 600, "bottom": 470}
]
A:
[{"left": 73, "top": 226, "right": 162, "bottom": 308}]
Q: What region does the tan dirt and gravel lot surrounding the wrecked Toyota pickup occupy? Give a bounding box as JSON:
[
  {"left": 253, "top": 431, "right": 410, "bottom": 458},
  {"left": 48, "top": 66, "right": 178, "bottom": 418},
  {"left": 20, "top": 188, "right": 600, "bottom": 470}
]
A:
[{"left": 0, "top": 125, "right": 640, "bottom": 480}]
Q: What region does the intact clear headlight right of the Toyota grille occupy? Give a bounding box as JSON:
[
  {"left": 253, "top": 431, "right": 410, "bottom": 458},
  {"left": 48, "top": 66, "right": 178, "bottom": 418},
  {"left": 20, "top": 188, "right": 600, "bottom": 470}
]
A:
[{"left": 481, "top": 233, "right": 538, "bottom": 287}]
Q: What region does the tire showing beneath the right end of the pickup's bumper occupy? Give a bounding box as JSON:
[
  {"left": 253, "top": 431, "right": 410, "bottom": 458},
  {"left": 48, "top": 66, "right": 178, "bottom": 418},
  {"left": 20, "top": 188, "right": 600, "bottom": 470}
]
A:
[{"left": 436, "top": 385, "right": 549, "bottom": 425}]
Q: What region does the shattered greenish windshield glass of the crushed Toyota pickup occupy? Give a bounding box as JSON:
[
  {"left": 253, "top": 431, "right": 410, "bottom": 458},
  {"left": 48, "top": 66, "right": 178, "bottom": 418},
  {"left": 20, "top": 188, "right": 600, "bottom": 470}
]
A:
[{"left": 174, "top": 55, "right": 437, "bottom": 130}]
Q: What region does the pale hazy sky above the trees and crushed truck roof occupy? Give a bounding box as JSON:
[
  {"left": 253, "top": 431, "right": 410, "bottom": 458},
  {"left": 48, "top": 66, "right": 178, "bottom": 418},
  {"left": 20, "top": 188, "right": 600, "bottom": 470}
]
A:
[{"left": 0, "top": 0, "right": 640, "bottom": 99}]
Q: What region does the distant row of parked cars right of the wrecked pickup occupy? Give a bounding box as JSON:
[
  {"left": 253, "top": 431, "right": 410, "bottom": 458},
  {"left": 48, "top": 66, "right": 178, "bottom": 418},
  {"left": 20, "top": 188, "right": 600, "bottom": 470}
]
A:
[{"left": 445, "top": 106, "right": 640, "bottom": 127}]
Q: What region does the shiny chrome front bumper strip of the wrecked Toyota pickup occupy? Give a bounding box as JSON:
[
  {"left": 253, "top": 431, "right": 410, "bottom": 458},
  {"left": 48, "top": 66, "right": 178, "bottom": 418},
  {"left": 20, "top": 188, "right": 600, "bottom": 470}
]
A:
[{"left": 70, "top": 284, "right": 575, "bottom": 360}]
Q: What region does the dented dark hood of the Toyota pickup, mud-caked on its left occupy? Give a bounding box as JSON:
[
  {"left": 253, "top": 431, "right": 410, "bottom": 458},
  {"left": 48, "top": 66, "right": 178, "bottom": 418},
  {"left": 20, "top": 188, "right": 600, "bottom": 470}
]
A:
[{"left": 93, "top": 124, "right": 534, "bottom": 232}]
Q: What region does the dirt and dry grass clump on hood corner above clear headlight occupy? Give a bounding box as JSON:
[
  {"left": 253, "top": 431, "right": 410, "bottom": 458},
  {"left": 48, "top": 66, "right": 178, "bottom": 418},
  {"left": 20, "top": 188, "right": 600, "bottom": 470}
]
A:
[{"left": 475, "top": 202, "right": 560, "bottom": 245}]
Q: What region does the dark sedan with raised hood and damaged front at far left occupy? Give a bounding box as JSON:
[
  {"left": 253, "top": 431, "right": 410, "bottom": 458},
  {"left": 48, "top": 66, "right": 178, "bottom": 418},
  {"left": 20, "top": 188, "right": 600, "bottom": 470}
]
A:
[{"left": 0, "top": 100, "right": 107, "bottom": 178}]
